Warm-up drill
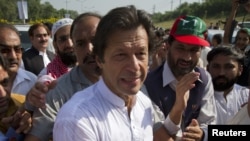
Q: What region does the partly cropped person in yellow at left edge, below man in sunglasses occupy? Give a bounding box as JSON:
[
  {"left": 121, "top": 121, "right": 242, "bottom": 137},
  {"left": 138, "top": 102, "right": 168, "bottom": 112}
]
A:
[{"left": 0, "top": 54, "right": 31, "bottom": 141}]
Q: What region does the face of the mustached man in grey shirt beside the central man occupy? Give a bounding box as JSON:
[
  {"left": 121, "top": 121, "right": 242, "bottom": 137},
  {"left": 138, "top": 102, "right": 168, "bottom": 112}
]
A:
[{"left": 72, "top": 16, "right": 100, "bottom": 76}]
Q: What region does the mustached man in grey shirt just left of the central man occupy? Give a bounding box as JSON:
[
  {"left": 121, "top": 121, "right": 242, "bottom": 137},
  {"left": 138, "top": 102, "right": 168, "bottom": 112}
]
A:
[{"left": 25, "top": 13, "right": 101, "bottom": 141}]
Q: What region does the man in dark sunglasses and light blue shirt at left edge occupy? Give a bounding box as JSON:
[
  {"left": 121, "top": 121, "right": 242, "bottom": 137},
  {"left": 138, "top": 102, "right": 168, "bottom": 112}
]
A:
[{"left": 0, "top": 23, "right": 37, "bottom": 95}]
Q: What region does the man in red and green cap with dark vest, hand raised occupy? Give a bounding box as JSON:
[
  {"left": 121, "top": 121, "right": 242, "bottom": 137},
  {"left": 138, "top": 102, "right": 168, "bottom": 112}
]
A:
[{"left": 145, "top": 16, "right": 216, "bottom": 141}]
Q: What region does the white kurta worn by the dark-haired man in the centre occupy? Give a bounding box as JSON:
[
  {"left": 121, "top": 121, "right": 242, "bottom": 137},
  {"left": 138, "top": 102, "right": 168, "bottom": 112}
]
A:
[{"left": 53, "top": 79, "right": 153, "bottom": 141}]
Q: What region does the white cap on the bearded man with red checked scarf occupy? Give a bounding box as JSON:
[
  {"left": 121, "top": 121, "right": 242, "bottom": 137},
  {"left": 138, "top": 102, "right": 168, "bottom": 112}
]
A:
[{"left": 52, "top": 18, "right": 73, "bottom": 39}]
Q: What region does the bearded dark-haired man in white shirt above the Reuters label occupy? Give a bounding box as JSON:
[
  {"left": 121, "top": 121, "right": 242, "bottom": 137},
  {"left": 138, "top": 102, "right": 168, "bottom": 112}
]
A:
[{"left": 207, "top": 47, "right": 249, "bottom": 124}]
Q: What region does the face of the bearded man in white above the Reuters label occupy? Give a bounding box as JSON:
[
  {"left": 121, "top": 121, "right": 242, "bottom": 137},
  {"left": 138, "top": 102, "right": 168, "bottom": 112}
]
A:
[{"left": 207, "top": 54, "right": 242, "bottom": 91}]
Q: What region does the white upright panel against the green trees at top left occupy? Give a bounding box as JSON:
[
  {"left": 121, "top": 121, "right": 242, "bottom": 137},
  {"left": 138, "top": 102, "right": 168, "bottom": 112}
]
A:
[{"left": 17, "top": 0, "right": 28, "bottom": 20}]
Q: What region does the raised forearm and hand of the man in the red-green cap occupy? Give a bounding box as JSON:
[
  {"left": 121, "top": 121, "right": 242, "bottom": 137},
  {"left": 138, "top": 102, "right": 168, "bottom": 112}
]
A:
[{"left": 154, "top": 72, "right": 199, "bottom": 141}]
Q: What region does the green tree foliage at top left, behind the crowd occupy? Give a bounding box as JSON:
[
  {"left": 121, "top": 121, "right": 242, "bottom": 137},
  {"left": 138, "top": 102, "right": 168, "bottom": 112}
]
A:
[{"left": 0, "top": 0, "right": 78, "bottom": 23}]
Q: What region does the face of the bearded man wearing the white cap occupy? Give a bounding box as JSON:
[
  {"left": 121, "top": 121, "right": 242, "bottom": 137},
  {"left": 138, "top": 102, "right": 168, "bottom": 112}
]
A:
[{"left": 53, "top": 25, "right": 77, "bottom": 66}]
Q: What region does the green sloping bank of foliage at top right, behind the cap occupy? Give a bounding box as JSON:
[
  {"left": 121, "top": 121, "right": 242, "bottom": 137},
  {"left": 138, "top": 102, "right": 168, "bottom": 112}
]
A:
[{"left": 153, "top": 0, "right": 249, "bottom": 22}]
